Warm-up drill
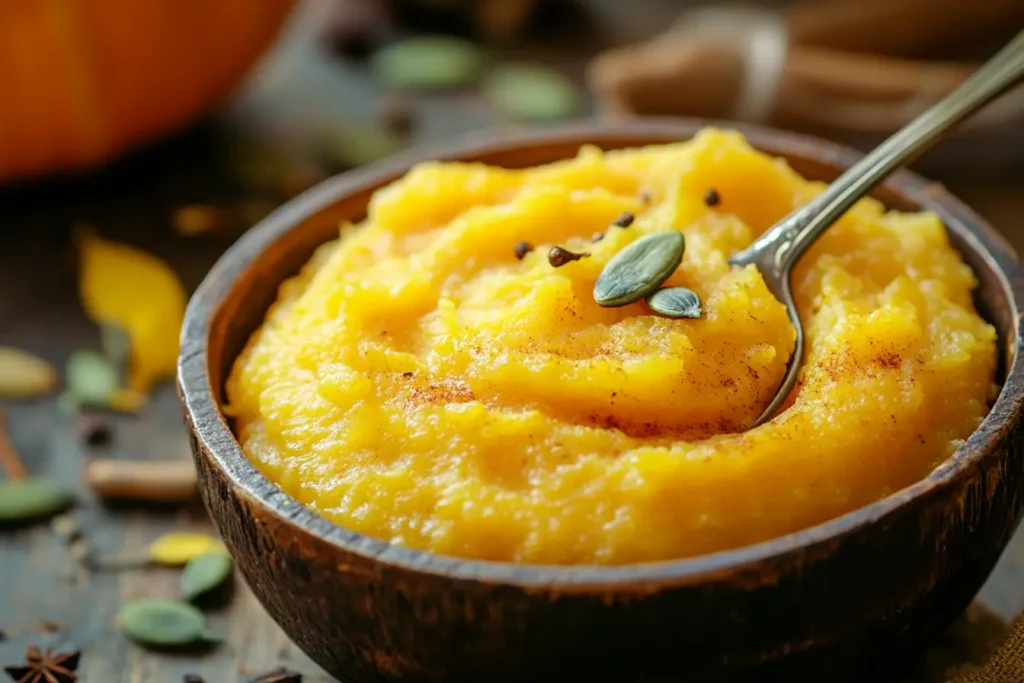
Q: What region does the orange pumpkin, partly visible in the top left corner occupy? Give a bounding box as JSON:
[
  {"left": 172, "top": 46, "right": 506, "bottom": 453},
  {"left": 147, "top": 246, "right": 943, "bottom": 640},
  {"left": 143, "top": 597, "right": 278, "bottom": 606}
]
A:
[{"left": 0, "top": 0, "right": 294, "bottom": 181}]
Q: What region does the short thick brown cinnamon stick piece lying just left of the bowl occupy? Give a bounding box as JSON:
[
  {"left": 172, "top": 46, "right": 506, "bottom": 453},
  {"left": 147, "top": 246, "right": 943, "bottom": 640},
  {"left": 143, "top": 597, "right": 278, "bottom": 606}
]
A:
[{"left": 84, "top": 458, "right": 199, "bottom": 503}]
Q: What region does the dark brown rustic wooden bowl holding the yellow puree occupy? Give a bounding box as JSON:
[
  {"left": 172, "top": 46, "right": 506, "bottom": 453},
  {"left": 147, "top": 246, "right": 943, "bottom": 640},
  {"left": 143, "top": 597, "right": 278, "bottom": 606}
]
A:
[{"left": 178, "top": 121, "right": 1024, "bottom": 683}]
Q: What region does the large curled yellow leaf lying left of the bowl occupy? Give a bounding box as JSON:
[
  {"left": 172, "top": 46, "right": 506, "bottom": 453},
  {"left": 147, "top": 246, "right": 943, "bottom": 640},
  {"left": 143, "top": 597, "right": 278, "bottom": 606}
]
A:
[{"left": 76, "top": 227, "right": 185, "bottom": 393}]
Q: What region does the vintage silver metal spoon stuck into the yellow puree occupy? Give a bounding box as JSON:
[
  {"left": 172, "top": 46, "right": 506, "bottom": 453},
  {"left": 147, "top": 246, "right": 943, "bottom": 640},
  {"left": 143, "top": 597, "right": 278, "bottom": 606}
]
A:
[{"left": 729, "top": 32, "right": 1024, "bottom": 427}]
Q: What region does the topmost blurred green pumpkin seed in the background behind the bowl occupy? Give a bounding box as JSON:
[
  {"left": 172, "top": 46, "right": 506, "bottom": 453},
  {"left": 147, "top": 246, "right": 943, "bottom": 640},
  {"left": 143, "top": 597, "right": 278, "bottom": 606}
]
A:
[{"left": 370, "top": 36, "right": 487, "bottom": 90}]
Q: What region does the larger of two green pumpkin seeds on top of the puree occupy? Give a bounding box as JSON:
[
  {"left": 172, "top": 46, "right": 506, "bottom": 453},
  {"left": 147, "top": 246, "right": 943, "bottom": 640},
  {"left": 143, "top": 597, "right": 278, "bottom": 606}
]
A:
[{"left": 594, "top": 230, "right": 685, "bottom": 307}]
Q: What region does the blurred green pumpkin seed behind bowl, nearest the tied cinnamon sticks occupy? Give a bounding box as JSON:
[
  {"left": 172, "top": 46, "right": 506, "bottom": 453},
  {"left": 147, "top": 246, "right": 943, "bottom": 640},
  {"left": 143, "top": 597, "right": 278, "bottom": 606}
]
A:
[{"left": 484, "top": 65, "right": 580, "bottom": 121}]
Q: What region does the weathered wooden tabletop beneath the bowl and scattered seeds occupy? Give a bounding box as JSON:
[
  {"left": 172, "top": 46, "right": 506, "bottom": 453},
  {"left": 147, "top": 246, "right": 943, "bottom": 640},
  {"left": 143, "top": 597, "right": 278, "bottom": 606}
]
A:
[{"left": 0, "top": 2, "right": 1024, "bottom": 683}]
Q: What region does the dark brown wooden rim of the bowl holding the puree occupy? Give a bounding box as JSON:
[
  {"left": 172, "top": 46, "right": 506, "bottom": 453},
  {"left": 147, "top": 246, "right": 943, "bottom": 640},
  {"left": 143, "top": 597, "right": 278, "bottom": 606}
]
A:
[{"left": 178, "top": 119, "right": 1024, "bottom": 590}]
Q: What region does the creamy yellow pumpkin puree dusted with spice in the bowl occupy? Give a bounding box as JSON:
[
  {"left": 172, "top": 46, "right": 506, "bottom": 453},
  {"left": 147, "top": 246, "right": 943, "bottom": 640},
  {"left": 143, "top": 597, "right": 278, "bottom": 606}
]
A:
[{"left": 227, "top": 130, "right": 995, "bottom": 564}]
